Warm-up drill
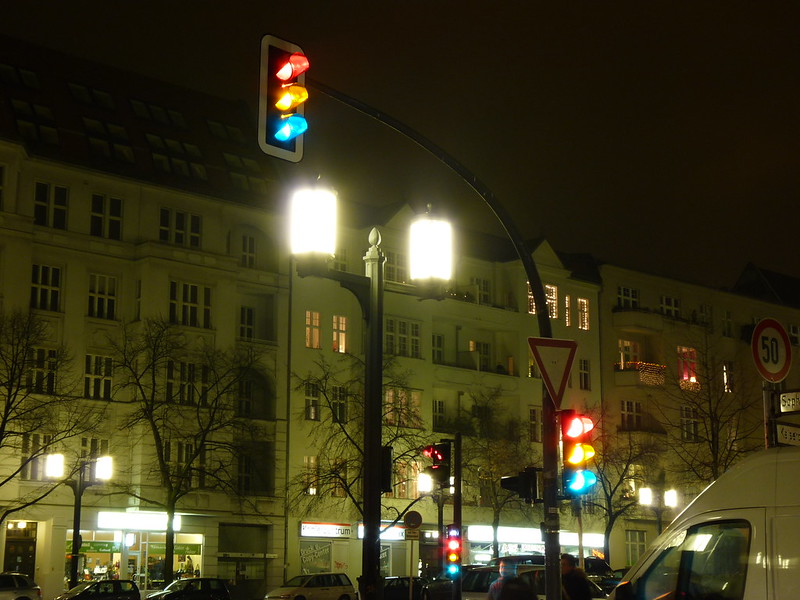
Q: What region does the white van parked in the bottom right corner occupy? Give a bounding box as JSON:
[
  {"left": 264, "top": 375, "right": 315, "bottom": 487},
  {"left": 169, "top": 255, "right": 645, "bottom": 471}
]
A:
[{"left": 611, "top": 447, "right": 800, "bottom": 600}]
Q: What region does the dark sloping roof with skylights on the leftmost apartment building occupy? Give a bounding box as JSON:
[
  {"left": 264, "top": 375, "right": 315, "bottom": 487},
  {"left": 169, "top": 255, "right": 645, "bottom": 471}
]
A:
[{"left": 0, "top": 36, "right": 280, "bottom": 205}]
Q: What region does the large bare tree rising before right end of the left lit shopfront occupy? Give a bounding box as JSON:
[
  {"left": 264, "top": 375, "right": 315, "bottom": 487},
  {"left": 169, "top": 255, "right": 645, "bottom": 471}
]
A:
[{"left": 111, "top": 319, "right": 260, "bottom": 582}]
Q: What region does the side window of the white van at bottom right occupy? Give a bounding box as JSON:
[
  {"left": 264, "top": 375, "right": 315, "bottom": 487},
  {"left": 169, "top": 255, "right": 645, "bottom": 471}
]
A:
[{"left": 626, "top": 520, "right": 750, "bottom": 600}]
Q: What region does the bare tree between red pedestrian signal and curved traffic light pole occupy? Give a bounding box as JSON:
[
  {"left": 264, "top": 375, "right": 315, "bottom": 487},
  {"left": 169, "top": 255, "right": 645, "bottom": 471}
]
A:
[{"left": 463, "top": 386, "right": 540, "bottom": 557}]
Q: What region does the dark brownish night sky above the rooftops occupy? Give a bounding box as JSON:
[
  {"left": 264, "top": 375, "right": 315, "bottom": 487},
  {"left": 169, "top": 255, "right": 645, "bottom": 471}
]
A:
[{"left": 0, "top": 0, "right": 800, "bottom": 286}]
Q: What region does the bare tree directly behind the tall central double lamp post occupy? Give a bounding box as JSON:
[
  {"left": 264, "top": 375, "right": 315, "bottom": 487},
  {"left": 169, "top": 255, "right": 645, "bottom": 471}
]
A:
[{"left": 289, "top": 354, "right": 430, "bottom": 522}]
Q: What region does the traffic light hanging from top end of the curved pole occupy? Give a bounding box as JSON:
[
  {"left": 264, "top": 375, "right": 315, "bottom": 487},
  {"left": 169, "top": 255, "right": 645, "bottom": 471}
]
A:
[{"left": 258, "top": 35, "right": 309, "bottom": 162}]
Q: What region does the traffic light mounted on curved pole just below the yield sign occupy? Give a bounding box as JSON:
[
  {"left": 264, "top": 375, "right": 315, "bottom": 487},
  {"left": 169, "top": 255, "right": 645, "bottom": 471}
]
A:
[{"left": 560, "top": 410, "right": 597, "bottom": 496}]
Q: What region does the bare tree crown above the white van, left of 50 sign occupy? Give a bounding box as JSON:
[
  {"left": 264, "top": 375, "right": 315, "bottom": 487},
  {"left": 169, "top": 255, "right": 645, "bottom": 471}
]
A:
[{"left": 654, "top": 326, "right": 763, "bottom": 485}]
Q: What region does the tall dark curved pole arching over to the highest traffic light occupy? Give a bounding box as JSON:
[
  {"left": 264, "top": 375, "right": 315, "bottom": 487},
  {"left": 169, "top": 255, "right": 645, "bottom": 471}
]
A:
[{"left": 306, "top": 78, "right": 561, "bottom": 600}]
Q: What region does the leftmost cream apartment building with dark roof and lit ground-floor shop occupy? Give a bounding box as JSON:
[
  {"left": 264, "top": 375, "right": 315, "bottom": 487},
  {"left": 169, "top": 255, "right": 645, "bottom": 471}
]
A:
[{"left": 0, "top": 39, "right": 288, "bottom": 597}]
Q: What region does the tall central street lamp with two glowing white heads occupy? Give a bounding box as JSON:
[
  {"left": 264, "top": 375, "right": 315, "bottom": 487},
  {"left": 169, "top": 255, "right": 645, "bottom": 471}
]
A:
[{"left": 289, "top": 188, "right": 452, "bottom": 600}]
